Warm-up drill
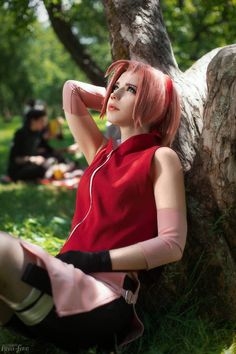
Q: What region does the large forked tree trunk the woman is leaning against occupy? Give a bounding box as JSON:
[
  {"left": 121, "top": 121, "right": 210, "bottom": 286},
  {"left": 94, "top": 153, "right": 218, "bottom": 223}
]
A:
[{"left": 104, "top": 0, "right": 236, "bottom": 320}]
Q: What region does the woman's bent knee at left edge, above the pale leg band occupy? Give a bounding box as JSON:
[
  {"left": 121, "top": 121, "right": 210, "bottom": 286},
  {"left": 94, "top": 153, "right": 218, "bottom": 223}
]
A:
[{"left": 0, "top": 232, "right": 35, "bottom": 303}]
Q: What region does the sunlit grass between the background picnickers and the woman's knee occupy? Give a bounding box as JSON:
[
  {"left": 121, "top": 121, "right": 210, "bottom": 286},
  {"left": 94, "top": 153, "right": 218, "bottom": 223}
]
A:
[{"left": 0, "top": 183, "right": 75, "bottom": 255}]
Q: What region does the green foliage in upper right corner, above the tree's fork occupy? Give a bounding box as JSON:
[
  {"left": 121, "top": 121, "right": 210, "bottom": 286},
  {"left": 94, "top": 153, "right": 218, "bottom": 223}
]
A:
[{"left": 161, "top": 0, "right": 236, "bottom": 70}]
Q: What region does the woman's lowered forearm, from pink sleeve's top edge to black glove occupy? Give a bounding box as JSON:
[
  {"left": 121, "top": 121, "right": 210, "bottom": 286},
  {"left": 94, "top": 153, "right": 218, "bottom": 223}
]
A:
[{"left": 110, "top": 208, "right": 187, "bottom": 270}]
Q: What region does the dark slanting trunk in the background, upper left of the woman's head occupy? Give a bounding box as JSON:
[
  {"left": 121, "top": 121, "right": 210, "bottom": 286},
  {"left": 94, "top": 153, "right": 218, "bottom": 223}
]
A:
[{"left": 44, "top": 1, "right": 105, "bottom": 86}]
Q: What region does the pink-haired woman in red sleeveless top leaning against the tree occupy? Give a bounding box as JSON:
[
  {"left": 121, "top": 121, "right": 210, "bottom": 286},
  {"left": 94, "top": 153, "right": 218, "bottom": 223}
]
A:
[{"left": 0, "top": 60, "right": 186, "bottom": 350}]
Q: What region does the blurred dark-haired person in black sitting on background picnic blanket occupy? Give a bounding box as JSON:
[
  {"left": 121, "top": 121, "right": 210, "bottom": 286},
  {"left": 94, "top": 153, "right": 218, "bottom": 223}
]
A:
[{"left": 7, "top": 109, "right": 75, "bottom": 181}]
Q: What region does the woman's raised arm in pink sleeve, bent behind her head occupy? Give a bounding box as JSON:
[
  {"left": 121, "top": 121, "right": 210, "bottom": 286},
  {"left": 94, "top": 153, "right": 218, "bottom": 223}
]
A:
[{"left": 63, "top": 80, "right": 107, "bottom": 164}]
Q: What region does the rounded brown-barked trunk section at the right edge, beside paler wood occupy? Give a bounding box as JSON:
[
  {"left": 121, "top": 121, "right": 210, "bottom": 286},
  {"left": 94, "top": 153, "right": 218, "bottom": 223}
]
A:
[{"left": 201, "top": 45, "right": 236, "bottom": 260}]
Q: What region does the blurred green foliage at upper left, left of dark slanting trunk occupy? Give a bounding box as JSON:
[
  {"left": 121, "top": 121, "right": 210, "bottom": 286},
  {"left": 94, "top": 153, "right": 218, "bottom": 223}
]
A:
[{"left": 0, "top": 2, "right": 86, "bottom": 115}]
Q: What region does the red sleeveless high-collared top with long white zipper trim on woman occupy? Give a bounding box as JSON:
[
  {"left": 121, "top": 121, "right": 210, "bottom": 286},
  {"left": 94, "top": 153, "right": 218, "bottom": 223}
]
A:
[{"left": 61, "top": 133, "right": 160, "bottom": 253}]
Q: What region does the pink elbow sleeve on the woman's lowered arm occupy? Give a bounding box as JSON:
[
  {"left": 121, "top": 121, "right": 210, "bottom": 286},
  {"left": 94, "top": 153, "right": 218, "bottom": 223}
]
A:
[{"left": 139, "top": 208, "right": 187, "bottom": 269}]
